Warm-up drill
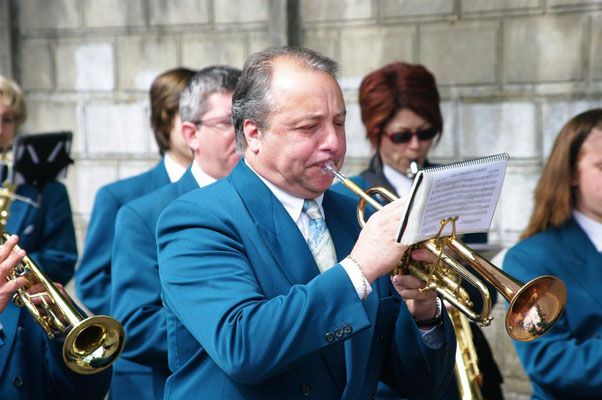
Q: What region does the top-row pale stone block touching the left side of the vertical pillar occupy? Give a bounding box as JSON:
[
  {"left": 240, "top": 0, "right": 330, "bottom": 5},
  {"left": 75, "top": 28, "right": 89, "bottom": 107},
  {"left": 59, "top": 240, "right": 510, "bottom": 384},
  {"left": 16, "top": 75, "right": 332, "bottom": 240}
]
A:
[{"left": 213, "top": 0, "right": 269, "bottom": 24}]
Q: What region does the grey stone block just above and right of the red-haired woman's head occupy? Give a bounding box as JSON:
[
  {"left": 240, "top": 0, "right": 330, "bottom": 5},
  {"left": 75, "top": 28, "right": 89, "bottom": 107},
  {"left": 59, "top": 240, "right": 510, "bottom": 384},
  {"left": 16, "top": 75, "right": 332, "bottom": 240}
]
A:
[{"left": 419, "top": 22, "right": 499, "bottom": 85}]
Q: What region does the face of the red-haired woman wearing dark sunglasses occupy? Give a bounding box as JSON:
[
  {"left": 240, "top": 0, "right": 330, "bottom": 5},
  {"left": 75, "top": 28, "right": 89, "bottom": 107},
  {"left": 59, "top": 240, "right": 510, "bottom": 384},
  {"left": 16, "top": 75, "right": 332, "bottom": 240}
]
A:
[{"left": 378, "top": 108, "right": 433, "bottom": 174}]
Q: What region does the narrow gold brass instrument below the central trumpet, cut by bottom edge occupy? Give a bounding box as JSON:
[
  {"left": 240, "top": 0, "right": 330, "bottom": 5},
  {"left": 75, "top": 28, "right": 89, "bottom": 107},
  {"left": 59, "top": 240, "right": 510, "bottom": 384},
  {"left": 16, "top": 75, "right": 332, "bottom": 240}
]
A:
[{"left": 447, "top": 307, "right": 483, "bottom": 400}]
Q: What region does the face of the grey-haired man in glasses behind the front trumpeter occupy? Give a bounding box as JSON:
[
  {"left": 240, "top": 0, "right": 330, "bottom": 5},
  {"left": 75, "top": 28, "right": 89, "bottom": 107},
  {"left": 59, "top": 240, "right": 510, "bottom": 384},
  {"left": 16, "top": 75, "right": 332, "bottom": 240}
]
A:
[{"left": 191, "top": 92, "right": 239, "bottom": 179}]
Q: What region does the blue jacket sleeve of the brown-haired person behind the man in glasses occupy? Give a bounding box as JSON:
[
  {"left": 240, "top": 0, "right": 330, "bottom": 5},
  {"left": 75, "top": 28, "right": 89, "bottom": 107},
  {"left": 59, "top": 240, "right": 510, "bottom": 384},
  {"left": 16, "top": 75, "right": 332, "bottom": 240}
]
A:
[{"left": 75, "top": 188, "right": 120, "bottom": 315}]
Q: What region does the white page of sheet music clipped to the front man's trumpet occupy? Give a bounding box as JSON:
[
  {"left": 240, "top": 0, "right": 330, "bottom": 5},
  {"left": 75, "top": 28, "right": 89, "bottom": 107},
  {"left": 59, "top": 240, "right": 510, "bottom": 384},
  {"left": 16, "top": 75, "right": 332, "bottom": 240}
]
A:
[{"left": 416, "top": 160, "right": 507, "bottom": 241}]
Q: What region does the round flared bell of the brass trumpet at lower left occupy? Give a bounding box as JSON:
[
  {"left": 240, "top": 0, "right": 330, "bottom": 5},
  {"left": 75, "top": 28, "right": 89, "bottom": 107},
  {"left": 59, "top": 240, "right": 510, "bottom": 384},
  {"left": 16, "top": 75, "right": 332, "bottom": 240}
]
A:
[{"left": 63, "top": 315, "right": 125, "bottom": 375}]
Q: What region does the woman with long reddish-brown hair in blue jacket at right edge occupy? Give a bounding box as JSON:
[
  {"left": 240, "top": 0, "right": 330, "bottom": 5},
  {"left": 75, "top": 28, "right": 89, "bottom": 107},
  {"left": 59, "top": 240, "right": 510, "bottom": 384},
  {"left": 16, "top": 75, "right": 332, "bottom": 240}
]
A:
[{"left": 504, "top": 108, "right": 602, "bottom": 399}]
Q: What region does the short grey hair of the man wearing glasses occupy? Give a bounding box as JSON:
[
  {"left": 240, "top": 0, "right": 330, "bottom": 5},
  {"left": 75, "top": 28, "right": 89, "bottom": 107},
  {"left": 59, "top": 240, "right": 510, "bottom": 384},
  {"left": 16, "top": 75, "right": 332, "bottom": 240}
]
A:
[{"left": 180, "top": 65, "right": 241, "bottom": 122}]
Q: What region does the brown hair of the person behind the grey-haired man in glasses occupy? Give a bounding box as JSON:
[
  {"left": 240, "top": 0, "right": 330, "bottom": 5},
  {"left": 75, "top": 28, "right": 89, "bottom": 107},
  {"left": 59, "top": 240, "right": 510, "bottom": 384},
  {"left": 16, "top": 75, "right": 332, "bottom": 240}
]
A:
[{"left": 150, "top": 68, "right": 194, "bottom": 155}]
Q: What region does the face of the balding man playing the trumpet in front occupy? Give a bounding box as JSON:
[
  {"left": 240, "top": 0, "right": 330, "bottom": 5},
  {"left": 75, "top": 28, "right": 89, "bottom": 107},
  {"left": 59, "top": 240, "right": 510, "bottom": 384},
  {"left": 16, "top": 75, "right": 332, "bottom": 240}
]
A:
[{"left": 244, "top": 60, "right": 346, "bottom": 198}]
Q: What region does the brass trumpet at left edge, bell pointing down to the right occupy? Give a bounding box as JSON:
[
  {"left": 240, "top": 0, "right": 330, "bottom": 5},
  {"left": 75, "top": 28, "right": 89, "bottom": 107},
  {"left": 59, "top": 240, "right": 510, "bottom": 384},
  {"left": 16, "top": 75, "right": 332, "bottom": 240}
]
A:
[{"left": 0, "top": 152, "right": 125, "bottom": 375}]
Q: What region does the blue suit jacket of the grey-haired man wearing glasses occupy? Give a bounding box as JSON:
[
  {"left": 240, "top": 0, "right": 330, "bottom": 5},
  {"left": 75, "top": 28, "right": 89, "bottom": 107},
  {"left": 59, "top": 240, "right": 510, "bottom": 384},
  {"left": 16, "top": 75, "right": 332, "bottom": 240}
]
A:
[{"left": 111, "top": 168, "right": 199, "bottom": 400}]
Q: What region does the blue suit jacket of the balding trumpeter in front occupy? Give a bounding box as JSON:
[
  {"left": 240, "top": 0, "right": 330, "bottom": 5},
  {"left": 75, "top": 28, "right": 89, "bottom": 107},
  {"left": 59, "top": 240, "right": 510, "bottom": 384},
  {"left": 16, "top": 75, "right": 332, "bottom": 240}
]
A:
[{"left": 157, "top": 161, "right": 455, "bottom": 399}]
